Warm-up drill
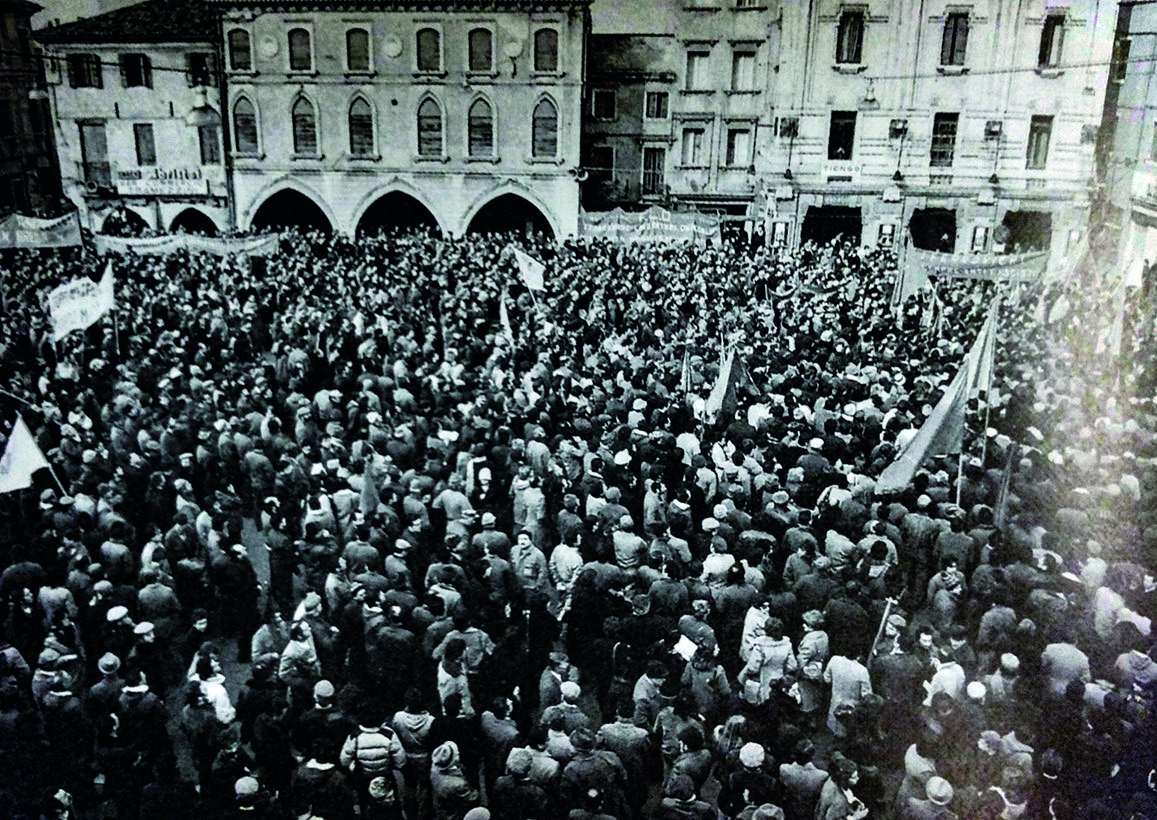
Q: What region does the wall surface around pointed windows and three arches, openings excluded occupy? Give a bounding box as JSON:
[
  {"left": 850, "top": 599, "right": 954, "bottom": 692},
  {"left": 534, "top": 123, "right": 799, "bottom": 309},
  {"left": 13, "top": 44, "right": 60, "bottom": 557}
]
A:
[{"left": 223, "top": 5, "right": 585, "bottom": 235}]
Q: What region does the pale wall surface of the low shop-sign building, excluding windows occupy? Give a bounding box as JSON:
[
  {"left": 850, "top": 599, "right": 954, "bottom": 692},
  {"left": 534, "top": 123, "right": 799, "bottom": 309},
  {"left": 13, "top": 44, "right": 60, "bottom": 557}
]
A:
[{"left": 43, "top": 43, "right": 229, "bottom": 231}]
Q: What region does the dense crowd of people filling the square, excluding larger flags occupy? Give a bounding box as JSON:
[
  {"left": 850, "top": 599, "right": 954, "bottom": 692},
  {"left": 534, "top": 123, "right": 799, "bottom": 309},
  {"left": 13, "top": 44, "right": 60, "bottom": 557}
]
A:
[{"left": 0, "top": 224, "right": 1157, "bottom": 820}]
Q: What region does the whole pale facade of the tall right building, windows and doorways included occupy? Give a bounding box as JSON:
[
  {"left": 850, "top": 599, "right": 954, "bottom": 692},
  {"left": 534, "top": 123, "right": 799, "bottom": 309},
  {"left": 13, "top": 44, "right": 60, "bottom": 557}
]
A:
[{"left": 761, "top": 0, "right": 1114, "bottom": 268}]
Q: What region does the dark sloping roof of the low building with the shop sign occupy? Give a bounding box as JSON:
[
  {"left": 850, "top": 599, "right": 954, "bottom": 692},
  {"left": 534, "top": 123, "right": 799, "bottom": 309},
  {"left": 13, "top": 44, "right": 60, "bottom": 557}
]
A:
[{"left": 32, "top": 0, "right": 218, "bottom": 45}]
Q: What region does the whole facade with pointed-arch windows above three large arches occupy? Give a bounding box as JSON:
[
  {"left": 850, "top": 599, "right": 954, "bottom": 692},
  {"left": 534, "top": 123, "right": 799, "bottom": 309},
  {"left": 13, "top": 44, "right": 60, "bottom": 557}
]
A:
[{"left": 214, "top": 0, "right": 588, "bottom": 235}]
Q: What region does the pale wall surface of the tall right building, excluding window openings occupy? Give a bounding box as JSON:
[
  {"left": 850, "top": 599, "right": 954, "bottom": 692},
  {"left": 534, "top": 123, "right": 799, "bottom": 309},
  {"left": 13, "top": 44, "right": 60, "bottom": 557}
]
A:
[{"left": 760, "top": 0, "right": 1114, "bottom": 267}]
